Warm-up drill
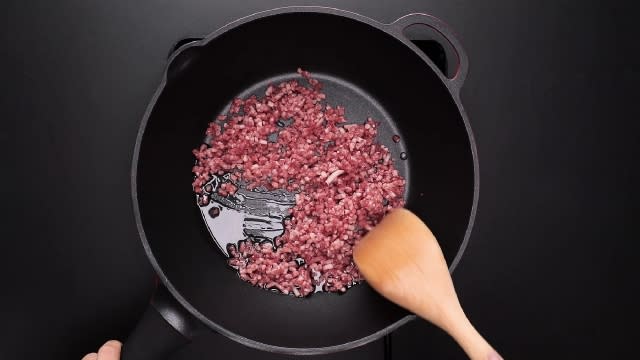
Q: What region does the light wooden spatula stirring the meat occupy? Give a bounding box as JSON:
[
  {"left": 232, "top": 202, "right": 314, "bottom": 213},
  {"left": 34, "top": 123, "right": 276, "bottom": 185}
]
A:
[{"left": 353, "top": 209, "right": 502, "bottom": 360}]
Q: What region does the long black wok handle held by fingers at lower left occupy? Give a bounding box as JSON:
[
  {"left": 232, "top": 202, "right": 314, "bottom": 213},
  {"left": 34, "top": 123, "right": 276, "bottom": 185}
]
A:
[{"left": 120, "top": 285, "right": 200, "bottom": 360}]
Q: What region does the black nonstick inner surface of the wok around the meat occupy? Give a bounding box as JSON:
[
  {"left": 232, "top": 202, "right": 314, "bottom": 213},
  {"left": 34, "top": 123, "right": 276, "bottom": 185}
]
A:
[{"left": 136, "top": 12, "right": 474, "bottom": 352}]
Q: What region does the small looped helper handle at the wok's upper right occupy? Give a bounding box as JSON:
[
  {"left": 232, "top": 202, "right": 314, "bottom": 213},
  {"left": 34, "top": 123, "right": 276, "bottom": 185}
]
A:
[{"left": 388, "top": 13, "right": 469, "bottom": 95}]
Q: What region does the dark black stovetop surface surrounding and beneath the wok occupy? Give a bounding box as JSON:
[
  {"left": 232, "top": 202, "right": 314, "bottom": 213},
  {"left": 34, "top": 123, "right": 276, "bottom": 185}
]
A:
[{"left": 0, "top": 0, "right": 640, "bottom": 360}]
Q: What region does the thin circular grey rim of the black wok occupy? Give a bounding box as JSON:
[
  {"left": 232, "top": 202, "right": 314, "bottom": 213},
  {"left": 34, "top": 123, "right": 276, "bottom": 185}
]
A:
[{"left": 130, "top": 6, "right": 479, "bottom": 355}]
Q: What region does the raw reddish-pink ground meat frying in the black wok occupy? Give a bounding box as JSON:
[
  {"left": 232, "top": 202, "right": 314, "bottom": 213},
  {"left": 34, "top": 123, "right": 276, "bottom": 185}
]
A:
[{"left": 193, "top": 69, "right": 405, "bottom": 296}]
